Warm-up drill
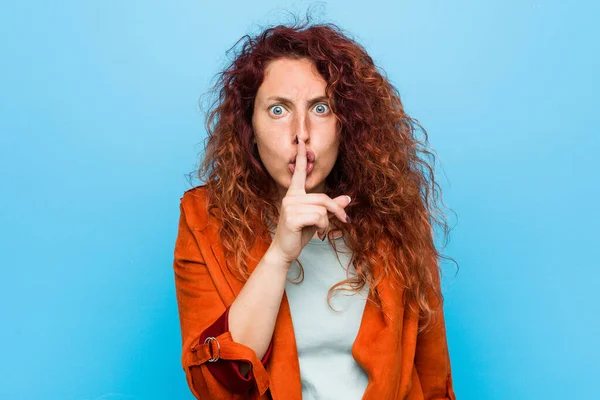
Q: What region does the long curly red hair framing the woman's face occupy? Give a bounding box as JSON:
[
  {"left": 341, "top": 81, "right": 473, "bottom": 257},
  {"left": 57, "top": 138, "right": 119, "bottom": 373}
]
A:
[{"left": 192, "top": 17, "right": 451, "bottom": 330}]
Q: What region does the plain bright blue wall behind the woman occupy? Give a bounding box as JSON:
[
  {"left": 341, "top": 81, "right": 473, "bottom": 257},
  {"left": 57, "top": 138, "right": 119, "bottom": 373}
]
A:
[{"left": 0, "top": 0, "right": 600, "bottom": 400}]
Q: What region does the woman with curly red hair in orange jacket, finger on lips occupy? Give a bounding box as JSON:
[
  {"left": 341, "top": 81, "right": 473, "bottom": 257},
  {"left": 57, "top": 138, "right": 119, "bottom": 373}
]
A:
[{"left": 174, "top": 18, "right": 455, "bottom": 400}]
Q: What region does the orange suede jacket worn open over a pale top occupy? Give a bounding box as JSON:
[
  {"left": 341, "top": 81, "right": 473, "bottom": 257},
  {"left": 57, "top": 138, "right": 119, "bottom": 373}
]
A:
[{"left": 173, "top": 186, "right": 455, "bottom": 400}]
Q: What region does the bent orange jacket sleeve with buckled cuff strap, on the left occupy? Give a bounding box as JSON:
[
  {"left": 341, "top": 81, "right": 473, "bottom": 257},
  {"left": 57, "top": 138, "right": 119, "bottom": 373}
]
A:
[{"left": 173, "top": 203, "right": 269, "bottom": 400}]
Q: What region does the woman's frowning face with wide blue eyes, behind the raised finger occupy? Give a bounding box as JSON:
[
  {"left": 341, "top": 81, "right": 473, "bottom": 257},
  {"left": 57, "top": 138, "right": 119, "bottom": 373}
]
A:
[{"left": 252, "top": 58, "right": 339, "bottom": 200}]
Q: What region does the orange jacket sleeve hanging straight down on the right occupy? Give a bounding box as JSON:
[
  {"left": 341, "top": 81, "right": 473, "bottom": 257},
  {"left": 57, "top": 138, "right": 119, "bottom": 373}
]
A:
[{"left": 415, "top": 268, "right": 456, "bottom": 400}]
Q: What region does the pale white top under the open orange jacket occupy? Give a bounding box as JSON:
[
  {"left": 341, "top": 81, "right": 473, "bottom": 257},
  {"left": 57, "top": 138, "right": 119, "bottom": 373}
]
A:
[{"left": 271, "top": 233, "right": 368, "bottom": 400}]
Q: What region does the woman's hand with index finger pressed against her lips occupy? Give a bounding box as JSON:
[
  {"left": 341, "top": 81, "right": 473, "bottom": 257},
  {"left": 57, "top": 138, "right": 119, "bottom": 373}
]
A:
[{"left": 270, "top": 139, "right": 351, "bottom": 264}]
